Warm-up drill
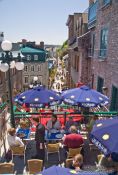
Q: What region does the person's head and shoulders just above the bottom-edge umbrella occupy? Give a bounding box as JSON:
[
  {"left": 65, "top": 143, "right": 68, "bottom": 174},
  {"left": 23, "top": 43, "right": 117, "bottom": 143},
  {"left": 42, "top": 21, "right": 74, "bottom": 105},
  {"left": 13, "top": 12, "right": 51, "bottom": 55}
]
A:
[{"left": 69, "top": 154, "right": 83, "bottom": 172}]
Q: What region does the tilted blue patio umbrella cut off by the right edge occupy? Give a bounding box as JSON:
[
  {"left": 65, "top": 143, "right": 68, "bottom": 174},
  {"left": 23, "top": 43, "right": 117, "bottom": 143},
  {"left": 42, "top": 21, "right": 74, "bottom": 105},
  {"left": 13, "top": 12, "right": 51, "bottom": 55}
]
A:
[{"left": 90, "top": 118, "right": 118, "bottom": 161}]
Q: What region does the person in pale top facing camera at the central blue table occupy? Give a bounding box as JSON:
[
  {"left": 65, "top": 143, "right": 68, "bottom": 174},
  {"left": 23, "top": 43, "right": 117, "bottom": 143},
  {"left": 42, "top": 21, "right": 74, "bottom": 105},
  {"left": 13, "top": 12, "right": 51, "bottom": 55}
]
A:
[{"left": 46, "top": 115, "right": 61, "bottom": 131}]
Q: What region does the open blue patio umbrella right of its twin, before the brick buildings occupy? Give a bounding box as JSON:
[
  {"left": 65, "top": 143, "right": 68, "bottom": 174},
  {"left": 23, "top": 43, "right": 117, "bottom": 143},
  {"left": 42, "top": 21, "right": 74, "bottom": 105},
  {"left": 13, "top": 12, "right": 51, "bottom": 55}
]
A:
[{"left": 61, "top": 85, "right": 109, "bottom": 107}]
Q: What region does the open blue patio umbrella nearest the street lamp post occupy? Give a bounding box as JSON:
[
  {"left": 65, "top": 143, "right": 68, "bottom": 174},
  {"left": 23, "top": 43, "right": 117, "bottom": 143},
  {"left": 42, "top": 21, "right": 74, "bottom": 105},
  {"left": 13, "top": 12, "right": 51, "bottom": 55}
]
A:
[{"left": 14, "top": 86, "right": 61, "bottom": 107}]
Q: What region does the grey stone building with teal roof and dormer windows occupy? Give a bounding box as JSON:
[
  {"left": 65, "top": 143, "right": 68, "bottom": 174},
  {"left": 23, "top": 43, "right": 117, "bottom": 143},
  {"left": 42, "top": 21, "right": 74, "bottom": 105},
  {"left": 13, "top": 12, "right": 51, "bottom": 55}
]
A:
[{"left": 21, "top": 46, "right": 49, "bottom": 90}]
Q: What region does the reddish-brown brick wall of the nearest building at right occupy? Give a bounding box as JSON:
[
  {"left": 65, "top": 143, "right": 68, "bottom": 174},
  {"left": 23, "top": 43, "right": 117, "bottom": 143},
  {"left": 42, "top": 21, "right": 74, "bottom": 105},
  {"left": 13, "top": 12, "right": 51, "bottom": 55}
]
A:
[{"left": 92, "top": 0, "right": 118, "bottom": 97}]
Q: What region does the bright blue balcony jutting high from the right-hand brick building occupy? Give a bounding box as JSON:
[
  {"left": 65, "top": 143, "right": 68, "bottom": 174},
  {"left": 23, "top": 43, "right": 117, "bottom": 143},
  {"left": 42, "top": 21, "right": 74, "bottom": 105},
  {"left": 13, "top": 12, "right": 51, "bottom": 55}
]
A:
[{"left": 88, "top": 1, "right": 98, "bottom": 29}]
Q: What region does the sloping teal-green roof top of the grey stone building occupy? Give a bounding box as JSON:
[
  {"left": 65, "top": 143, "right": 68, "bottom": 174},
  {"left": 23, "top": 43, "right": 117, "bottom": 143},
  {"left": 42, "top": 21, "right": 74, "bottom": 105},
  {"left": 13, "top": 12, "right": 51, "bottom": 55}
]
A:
[{"left": 21, "top": 46, "right": 46, "bottom": 54}]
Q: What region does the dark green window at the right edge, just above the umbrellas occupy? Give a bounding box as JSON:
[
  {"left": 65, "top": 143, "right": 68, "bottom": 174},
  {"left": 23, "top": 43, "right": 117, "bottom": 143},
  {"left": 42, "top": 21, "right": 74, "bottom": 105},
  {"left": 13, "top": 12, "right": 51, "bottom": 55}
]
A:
[{"left": 110, "top": 86, "right": 118, "bottom": 111}]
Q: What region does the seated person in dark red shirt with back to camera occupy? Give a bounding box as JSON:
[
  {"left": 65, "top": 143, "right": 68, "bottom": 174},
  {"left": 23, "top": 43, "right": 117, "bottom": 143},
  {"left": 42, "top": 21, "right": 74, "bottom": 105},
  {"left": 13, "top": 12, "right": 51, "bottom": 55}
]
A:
[{"left": 63, "top": 126, "right": 84, "bottom": 150}]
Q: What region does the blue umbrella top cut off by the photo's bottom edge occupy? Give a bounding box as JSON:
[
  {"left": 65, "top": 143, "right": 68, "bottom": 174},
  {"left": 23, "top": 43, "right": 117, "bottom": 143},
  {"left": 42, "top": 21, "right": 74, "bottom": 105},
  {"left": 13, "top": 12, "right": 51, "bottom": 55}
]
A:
[{"left": 38, "top": 166, "right": 107, "bottom": 175}]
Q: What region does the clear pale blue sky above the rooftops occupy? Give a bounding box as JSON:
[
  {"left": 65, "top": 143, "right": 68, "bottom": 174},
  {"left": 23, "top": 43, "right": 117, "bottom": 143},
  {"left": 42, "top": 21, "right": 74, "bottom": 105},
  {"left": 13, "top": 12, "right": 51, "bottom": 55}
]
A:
[{"left": 0, "top": 0, "right": 89, "bottom": 45}]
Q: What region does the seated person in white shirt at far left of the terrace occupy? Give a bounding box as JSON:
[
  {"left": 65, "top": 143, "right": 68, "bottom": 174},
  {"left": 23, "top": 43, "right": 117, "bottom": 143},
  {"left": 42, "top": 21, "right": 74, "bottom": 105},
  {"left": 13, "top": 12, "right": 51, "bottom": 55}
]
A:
[{"left": 7, "top": 128, "right": 24, "bottom": 146}]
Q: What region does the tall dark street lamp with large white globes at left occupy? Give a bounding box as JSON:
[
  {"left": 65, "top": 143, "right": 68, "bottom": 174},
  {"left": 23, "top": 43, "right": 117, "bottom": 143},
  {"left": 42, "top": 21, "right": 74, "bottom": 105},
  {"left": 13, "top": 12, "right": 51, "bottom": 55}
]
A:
[{"left": 0, "top": 40, "right": 24, "bottom": 127}]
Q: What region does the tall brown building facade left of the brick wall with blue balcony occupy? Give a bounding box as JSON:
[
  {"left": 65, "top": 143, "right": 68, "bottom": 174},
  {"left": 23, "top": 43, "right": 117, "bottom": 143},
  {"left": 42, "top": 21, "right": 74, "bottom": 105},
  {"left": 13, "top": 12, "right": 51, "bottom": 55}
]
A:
[{"left": 67, "top": 13, "right": 90, "bottom": 88}]
